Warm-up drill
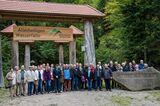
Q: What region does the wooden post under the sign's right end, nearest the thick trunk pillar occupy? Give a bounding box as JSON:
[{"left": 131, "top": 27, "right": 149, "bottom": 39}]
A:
[{"left": 69, "top": 38, "right": 76, "bottom": 64}]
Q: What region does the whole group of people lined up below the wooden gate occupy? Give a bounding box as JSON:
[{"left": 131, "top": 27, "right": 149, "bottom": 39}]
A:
[{"left": 6, "top": 60, "right": 148, "bottom": 97}]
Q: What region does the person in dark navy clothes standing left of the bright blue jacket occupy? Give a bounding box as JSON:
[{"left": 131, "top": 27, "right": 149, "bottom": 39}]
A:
[{"left": 53, "top": 64, "right": 61, "bottom": 93}]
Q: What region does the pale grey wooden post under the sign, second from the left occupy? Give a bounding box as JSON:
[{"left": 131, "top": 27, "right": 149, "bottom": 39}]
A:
[{"left": 24, "top": 44, "right": 30, "bottom": 70}]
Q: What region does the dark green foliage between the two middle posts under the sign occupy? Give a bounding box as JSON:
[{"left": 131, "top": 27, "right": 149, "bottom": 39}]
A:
[{"left": 31, "top": 41, "right": 58, "bottom": 65}]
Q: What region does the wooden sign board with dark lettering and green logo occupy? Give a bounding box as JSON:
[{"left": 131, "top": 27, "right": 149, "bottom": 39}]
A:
[{"left": 13, "top": 26, "right": 73, "bottom": 42}]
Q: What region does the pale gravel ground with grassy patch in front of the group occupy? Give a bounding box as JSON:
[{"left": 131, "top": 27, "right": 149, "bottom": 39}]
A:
[{"left": 0, "top": 90, "right": 160, "bottom": 106}]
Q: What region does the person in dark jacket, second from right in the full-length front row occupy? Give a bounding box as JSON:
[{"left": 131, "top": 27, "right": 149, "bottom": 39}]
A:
[{"left": 95, "top": 64, "right": 103, "bottom": 91}]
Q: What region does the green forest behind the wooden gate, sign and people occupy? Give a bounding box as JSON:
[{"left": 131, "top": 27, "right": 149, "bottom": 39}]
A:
[{"left": 0, "top": 0, "right": 160, "bottom": 74}]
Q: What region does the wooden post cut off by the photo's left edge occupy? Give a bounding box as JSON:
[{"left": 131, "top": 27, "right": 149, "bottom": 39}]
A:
[{"left": 0, "top": 34, "right": 4, "bottom": 87}]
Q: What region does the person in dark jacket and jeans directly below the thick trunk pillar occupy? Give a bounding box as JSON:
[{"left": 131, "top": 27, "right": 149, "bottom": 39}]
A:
[{"left": 87, "top": 67, "right": 94, "bottom": 91}]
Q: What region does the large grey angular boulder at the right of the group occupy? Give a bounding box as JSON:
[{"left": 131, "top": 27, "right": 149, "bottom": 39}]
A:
[{"left": 113, "top": 67, "right": 160, "bottom": 91}]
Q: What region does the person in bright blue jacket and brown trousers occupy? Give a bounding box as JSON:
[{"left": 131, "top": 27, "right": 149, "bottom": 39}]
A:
[{"left": 64, "top": 64, "right": 71, "bottom": 91}]
